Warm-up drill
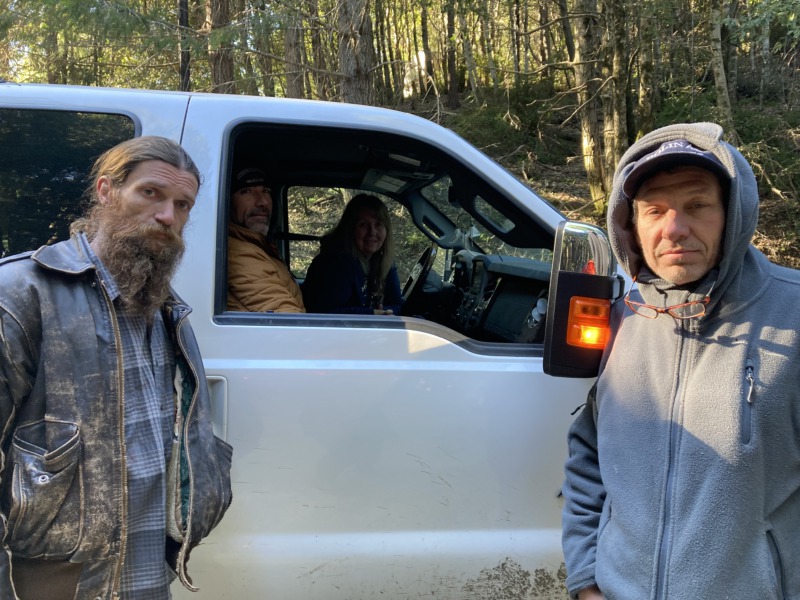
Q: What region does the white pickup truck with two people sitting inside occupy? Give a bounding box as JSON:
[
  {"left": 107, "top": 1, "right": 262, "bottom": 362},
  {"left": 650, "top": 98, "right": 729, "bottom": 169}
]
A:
[{"left": 0, "top": 83, "right": 616, "bottom": 600}]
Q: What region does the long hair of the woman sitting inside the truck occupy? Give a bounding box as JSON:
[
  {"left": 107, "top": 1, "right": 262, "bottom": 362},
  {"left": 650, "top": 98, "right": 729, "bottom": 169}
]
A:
[{"left": 321, "top": 194, "right": 394, "bottom": 291}]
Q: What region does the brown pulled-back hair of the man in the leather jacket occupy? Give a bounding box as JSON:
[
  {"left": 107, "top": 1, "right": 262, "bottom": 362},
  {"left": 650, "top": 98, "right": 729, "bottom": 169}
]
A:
[{"left": 70, "top": 135, "right": 202, "bottom": 238}]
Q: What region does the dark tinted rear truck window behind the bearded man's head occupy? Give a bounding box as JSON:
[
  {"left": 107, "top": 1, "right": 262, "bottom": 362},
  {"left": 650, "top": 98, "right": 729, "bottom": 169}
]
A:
[{"left": 0, "top": 108, "right": 135, "bottom": 256}]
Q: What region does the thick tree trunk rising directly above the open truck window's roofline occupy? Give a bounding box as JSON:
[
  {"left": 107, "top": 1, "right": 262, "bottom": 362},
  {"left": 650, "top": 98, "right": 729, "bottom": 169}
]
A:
[{"left": 339, "top": 0, "right": 373, "bottom": 104}]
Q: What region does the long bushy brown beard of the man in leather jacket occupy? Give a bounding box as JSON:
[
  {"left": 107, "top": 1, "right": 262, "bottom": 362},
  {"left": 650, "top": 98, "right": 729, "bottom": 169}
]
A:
[{"left": 91, "top": 205, "right": 185, "bottom": 319}]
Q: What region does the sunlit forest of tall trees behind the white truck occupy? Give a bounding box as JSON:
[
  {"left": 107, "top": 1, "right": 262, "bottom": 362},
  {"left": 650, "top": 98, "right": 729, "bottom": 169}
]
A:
[{"left": 0, "top": 0, "right": 800, "bottom": 268}]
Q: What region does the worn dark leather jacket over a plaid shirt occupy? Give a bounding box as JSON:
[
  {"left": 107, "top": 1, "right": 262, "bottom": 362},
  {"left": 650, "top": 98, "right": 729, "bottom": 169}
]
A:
[{"left": 0, "top": 237, "right": 231, "bottom": 600}]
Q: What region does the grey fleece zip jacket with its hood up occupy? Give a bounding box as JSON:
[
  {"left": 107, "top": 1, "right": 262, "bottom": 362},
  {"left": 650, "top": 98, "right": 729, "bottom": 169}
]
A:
[{"left": 563, "top": 123, "right": 800, "bottom": 600}]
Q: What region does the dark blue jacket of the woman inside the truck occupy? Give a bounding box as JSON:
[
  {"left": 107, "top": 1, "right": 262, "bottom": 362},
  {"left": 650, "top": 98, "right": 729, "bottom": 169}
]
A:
[{"left": 303, "top": 250, "right": 403, "bottom": 315}]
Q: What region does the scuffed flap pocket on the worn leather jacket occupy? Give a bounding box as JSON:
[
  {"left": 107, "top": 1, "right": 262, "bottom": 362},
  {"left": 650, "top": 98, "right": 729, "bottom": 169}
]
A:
[{"left": 2, "top": 420, "right": 84, "bottom": 559}]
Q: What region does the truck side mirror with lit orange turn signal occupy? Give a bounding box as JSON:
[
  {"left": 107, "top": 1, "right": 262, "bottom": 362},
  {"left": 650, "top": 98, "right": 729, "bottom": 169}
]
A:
[{"left": 543, "top": 221, "right": 624, "bottom": 377}]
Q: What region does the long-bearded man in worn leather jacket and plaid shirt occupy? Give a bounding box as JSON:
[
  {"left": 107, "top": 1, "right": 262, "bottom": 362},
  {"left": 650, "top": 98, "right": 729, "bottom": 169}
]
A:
[{"left": 0, "top": 137, "right": 231, "bottom": 600}]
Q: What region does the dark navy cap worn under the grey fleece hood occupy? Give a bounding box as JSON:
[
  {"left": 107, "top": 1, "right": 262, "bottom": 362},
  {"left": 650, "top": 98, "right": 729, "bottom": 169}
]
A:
[{"left": 622, "top": 139, "right": 730, "bottom": 198}]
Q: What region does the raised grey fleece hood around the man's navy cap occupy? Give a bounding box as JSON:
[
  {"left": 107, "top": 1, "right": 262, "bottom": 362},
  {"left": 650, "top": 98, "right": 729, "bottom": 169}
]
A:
[{"left": 607, "top": 123, "right": 758, "bottom": 310}]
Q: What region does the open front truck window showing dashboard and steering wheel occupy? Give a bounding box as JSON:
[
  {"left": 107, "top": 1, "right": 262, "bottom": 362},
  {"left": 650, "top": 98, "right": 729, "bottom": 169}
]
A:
[{"left": 216, "top": 123, "right": 552, "bottom": 352}]
